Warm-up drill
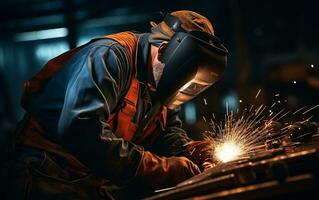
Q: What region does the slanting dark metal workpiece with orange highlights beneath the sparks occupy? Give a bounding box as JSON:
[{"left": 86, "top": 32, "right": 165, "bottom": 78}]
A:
[{"left": 146, "top": 136, "right": 319, "bottom": 200}]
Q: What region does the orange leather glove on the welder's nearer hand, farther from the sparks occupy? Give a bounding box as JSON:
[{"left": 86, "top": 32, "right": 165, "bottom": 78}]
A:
[{"left": 137, "top": 151, "right": 200, "bottom": 189}]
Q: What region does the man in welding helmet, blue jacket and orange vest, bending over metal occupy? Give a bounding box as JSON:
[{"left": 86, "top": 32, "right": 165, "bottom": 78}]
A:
[{"left": 11, "top": 11, "right": 228, "bottom": 199}]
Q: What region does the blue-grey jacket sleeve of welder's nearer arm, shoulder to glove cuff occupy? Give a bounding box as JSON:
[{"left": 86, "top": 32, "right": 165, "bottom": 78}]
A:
[{"left": 58, "top": 45, "right": 143, "bottom": 184}]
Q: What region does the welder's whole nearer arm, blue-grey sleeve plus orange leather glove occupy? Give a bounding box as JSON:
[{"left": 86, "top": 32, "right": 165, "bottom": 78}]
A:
[{"left": 58, "top": 43, "right": 199, "bottom": 188}]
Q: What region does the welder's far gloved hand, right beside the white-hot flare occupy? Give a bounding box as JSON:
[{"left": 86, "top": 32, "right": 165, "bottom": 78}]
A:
[{"left": 186, "top": 140, "right": 216, "bottom": 171}]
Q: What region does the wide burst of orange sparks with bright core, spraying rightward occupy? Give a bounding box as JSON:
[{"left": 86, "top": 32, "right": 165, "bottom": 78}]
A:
[{"left": 203, "top": 97, "right": 319, "bottom": 163}]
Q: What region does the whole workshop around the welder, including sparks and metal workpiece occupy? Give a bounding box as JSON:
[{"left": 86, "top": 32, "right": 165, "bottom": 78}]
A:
[{"left": 0, "top": 0, "right": 319, "bottom": 200}]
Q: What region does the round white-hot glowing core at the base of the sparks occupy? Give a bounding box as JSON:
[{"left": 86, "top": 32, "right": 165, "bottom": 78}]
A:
[{"left": 215, "top": 141, "right": 242, "bottom": 162}]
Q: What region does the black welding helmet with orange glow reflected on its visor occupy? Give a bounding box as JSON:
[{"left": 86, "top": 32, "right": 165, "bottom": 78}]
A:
[{"left": 157, "top": 14, "right": 228, "bottom": 109}]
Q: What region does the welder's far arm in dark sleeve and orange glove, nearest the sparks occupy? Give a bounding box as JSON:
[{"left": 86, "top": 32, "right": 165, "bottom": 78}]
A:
[{"left": 153, "top": 108, "right": 214, "bottom": 171}]
